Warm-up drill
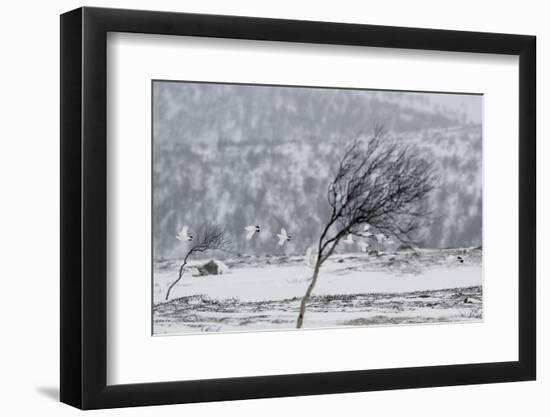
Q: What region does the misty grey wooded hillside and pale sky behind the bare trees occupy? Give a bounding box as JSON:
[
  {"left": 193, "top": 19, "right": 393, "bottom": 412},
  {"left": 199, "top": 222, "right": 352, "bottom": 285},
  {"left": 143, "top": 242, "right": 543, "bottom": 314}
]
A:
[{"left": 153, "top": 81, "right": 482, "bottom": 259}]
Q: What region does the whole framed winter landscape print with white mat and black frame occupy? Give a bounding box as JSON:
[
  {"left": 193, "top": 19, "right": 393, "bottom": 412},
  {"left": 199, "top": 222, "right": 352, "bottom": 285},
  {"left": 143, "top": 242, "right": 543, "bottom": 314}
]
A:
[{"left": 60, "top": 7, "right": 536, "bottom": 409}]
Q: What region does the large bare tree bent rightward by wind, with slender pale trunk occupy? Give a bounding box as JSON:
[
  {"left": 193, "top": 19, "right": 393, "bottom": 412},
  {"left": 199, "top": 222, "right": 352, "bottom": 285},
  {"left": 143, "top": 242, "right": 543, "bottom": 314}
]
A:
[{"left": 296, "top": 126, "right": 436, "bottom": 328}]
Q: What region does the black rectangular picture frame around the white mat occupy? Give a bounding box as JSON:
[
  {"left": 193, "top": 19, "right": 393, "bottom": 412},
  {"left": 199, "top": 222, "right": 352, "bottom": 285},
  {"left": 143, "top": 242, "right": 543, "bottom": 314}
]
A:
[{"left": 60, "top": 7, "right": 536, "bottom": 409}]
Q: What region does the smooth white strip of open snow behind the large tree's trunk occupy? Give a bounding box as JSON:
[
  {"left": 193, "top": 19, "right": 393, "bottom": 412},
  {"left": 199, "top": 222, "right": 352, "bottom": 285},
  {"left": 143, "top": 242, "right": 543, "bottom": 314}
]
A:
[{"left": 154, "top": 254, "right": 481, "bottom": 304}]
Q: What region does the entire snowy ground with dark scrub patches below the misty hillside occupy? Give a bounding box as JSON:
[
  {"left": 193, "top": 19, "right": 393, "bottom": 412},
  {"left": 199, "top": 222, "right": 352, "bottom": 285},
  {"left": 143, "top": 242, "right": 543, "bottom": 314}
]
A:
[{"left": 153, "top": 249, "right": 482, "bottom": 334}]
